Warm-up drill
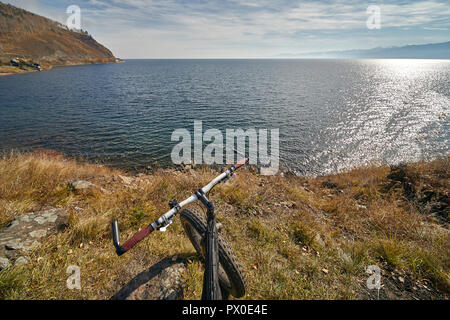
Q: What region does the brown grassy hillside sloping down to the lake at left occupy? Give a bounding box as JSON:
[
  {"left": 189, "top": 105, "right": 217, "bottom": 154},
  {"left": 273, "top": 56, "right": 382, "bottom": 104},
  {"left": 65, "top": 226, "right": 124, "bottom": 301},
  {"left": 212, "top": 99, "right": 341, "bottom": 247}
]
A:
[{"left": 0, "top": 2, "right": 116, "bottom": 68}]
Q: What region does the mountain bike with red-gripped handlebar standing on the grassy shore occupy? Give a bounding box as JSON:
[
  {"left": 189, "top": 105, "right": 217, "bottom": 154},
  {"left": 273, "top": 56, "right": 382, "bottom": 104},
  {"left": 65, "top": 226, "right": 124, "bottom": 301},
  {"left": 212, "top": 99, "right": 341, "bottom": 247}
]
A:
[{"left": 112, "top": 158, "right": 248, "bottom": 300}]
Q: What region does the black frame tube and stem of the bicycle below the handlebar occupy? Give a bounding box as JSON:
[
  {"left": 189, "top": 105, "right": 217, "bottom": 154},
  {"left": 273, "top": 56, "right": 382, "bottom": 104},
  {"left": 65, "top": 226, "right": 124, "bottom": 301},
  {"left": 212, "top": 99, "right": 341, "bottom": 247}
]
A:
[{"left": 197, "top": 190, "right": 222, "bottom": 300}]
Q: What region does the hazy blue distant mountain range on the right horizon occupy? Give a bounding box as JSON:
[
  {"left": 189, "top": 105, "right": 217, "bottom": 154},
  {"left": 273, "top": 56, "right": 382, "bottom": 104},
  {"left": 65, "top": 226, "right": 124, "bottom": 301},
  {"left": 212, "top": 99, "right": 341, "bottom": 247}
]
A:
[{"left": 277, "top": 41, "right": 450, "bottom": 59}]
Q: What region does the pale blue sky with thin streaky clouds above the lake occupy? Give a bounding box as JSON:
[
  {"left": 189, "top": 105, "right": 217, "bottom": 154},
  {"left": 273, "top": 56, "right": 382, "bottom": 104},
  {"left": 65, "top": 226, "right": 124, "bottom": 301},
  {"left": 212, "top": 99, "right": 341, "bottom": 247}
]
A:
[{"left": 1, "top": 0, "right": 450, "bottom": 59}]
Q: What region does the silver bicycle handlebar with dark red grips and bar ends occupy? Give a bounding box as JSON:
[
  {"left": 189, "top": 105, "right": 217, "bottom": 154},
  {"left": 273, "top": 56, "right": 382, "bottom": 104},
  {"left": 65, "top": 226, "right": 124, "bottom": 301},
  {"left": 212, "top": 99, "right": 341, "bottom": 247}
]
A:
[{"left": 112, "top": 158, "right": 249, "bottom": 256}]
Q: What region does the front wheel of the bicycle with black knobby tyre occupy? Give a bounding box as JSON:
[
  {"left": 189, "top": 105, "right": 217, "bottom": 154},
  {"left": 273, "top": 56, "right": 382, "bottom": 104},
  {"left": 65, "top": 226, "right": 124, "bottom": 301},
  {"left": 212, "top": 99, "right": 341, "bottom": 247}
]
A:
[{"left": 180, "top": 210, "right": 245, "bottom": 298}]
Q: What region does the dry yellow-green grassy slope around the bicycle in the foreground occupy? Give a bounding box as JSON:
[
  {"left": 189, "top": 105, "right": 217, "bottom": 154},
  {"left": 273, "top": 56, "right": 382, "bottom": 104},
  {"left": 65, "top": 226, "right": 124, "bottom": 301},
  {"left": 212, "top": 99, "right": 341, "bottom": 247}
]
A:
[{"left": 0, "top": 153, "right": 450, "bottom": 299}]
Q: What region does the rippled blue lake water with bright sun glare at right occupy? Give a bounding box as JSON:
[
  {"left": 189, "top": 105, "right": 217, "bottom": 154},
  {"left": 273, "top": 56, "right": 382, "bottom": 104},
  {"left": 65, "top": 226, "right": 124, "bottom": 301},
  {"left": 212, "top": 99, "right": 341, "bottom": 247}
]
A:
[{"left": 0, "top": 60, "right": 450, "bottom": 175}]
